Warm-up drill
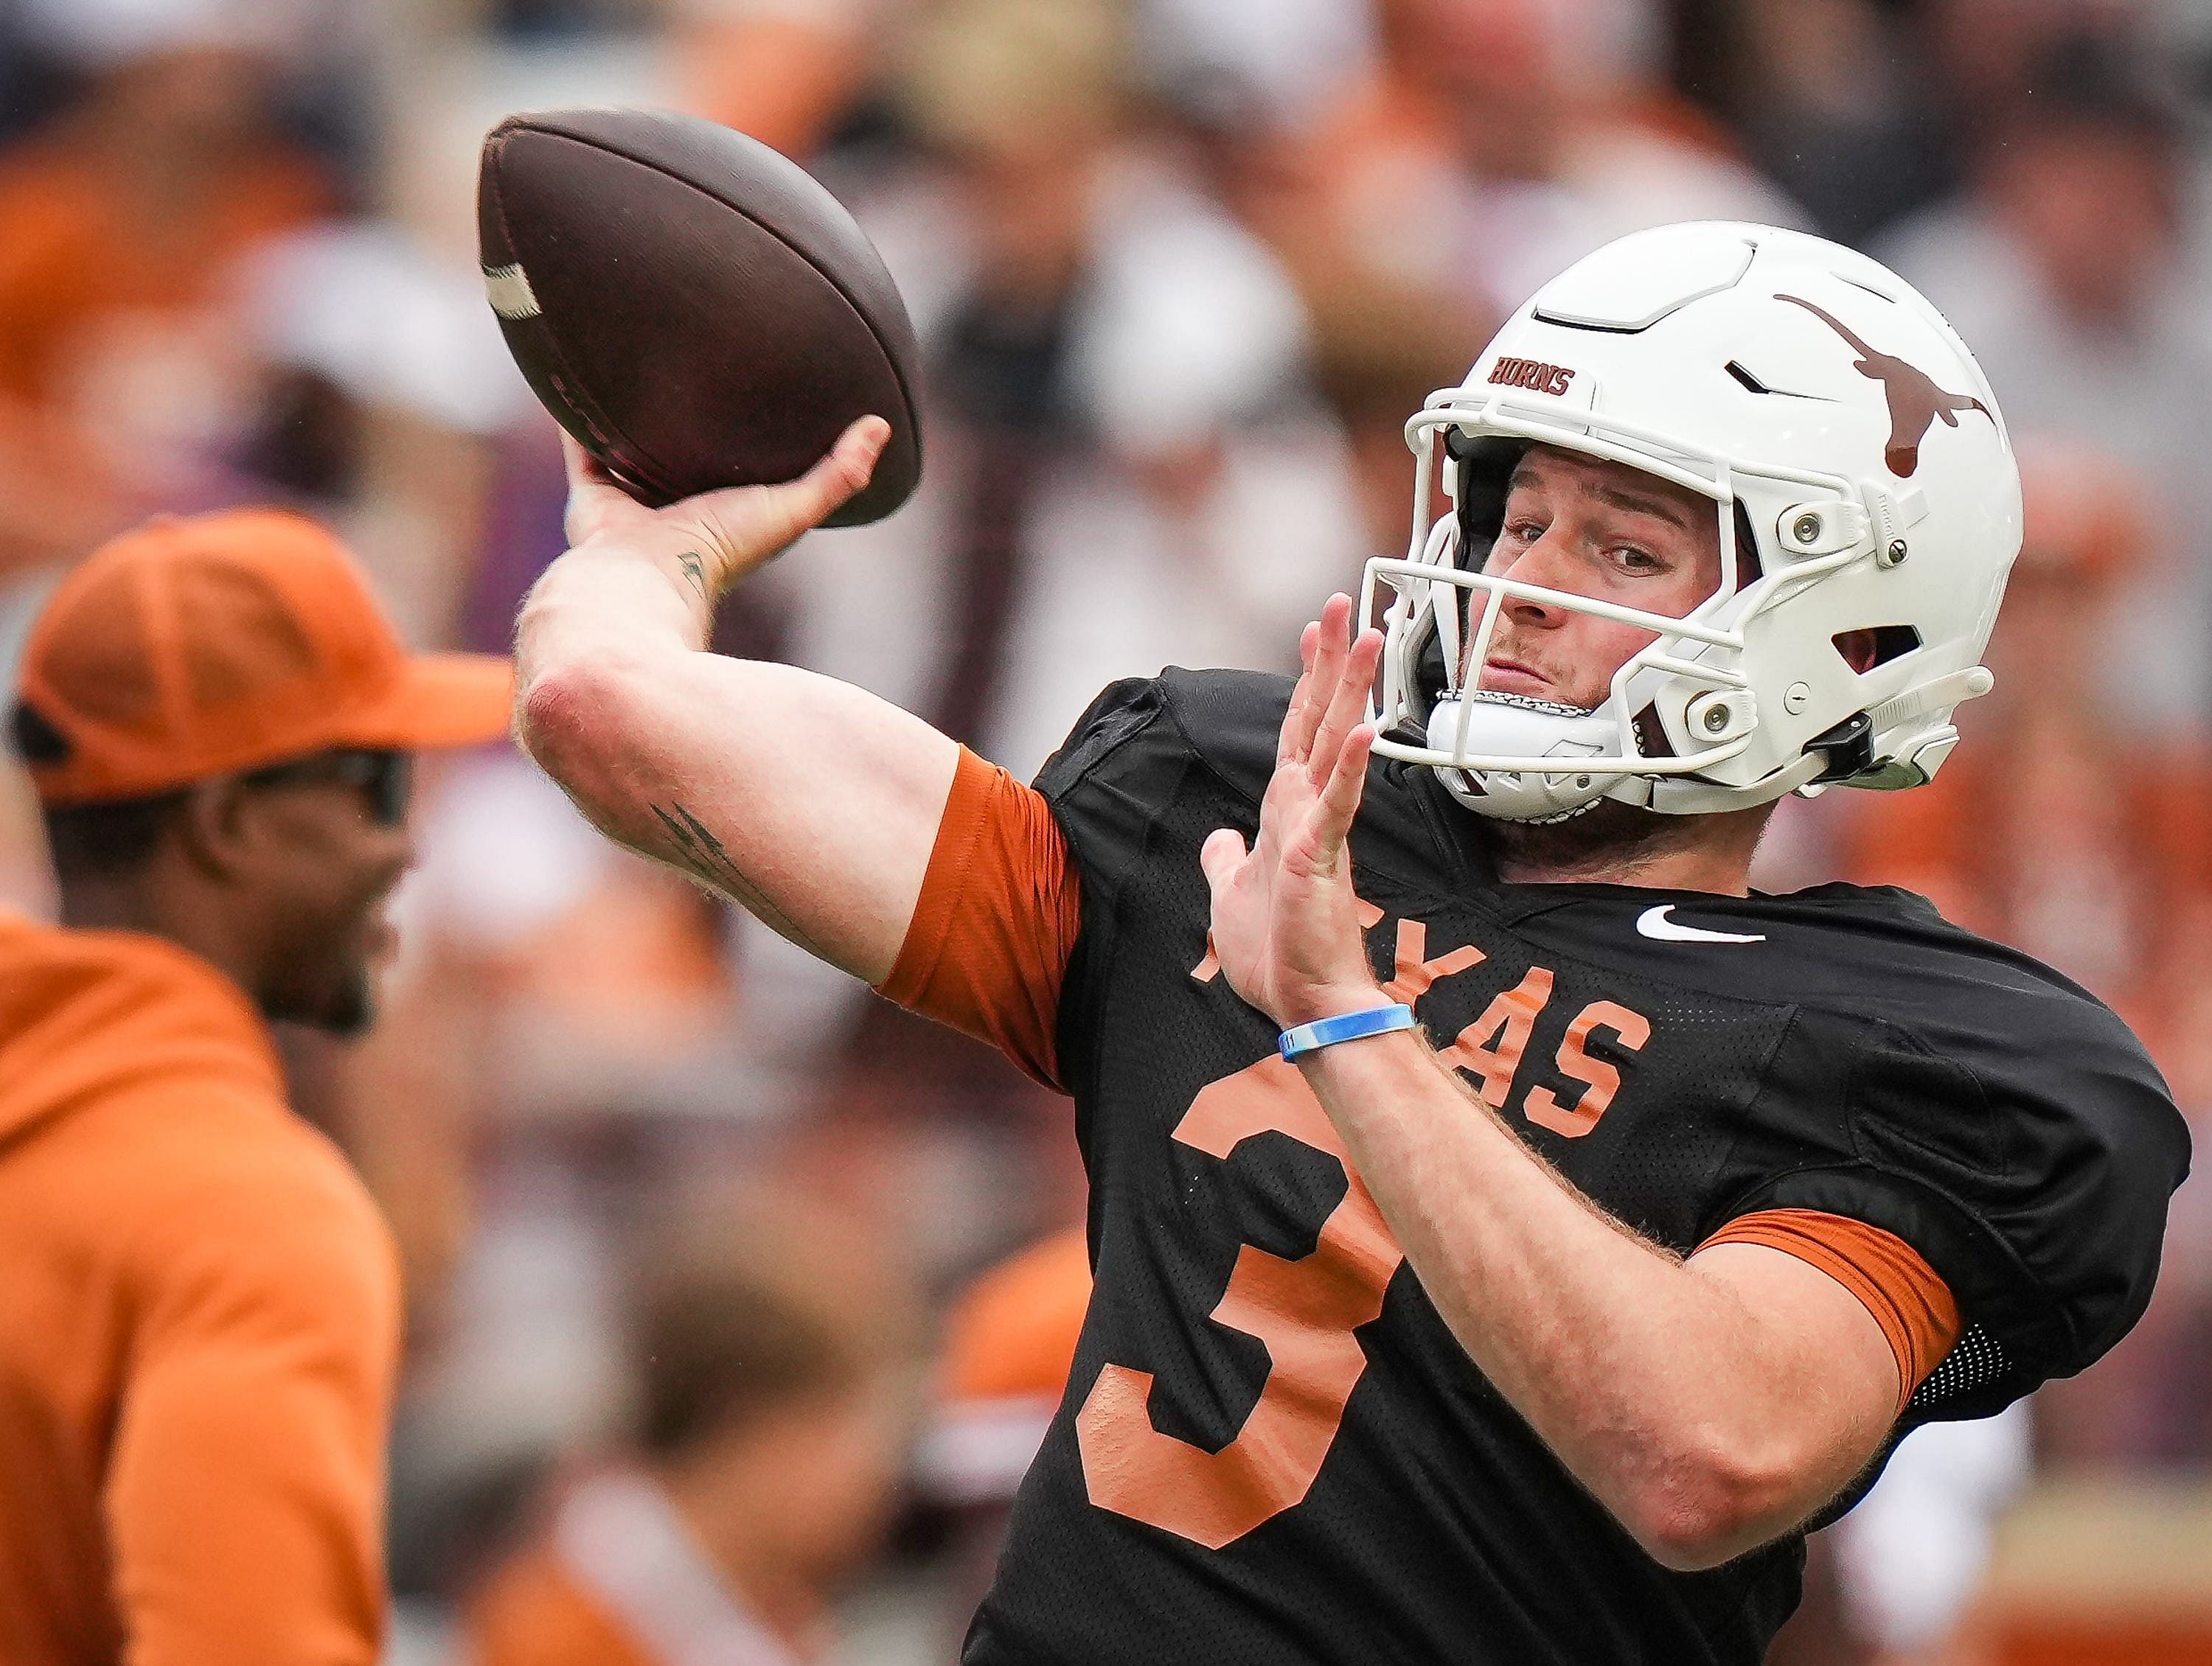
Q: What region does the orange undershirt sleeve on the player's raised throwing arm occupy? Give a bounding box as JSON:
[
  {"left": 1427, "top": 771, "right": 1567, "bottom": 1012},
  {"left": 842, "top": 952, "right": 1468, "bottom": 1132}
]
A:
[{"left": 876, "top": 747, "right": 1082, "bottom": 1091}]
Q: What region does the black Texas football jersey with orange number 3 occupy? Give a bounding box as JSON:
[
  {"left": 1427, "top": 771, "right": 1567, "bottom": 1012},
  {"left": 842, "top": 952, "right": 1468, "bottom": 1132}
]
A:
[{"left": 964, "top": 670, "right": 2188, "bottom": 1666}]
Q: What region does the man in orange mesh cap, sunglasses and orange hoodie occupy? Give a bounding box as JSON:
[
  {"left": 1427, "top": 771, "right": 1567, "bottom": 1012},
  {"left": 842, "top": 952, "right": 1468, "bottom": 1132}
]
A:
[{"left": 0, "top": 511, "right": 511, "bottom": 1666}]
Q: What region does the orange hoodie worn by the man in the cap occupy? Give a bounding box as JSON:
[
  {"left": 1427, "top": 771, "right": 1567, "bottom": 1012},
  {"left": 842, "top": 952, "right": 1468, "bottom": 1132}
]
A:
[{"left": 0, "top": 919, "right": 400, "bottom": 1666}]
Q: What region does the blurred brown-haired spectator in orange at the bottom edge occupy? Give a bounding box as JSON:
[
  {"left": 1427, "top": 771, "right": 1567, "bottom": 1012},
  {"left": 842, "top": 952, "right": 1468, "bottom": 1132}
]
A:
[{"left": 469, "top": 1197, "right": 920, "bottom": 1666}]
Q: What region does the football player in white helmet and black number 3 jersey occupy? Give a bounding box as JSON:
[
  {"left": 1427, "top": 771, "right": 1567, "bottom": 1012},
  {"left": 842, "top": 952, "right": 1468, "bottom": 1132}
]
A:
[{"left": 522, "top": 223, "right": 2188, "bottom": 1666}]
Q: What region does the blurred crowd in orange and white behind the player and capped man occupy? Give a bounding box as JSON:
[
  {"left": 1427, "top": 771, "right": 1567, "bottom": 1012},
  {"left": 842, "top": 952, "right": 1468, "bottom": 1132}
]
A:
[{"left": 0, "top": 0, "right": 2212, "bottom": 1666}]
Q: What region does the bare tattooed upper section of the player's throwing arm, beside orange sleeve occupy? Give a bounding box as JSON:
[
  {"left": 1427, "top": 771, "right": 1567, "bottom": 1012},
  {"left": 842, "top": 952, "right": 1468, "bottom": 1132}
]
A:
[{"left": 531, "top": 652, "right": 960, "bottom": 983}]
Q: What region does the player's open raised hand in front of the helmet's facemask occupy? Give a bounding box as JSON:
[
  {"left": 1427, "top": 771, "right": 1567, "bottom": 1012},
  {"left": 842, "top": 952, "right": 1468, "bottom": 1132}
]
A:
[{"left": 1199, "top": 595, "right": 1389, "bottom": 1029}]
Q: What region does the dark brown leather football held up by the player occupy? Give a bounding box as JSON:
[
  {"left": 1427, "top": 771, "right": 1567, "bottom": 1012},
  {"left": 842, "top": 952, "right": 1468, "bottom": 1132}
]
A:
[{"left": 476, "top": 111, "right": 922, "bottom": 526}]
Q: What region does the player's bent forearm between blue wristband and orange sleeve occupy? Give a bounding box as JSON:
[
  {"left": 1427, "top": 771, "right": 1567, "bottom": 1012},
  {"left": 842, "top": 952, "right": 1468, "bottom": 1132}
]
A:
[{"left": 1303, "top": 1036, "right": 1849, "bottom": 1566}]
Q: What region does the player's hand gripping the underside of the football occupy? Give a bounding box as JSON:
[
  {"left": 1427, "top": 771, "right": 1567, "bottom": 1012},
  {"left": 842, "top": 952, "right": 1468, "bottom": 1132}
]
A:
[{"left": 562, "top": 416, "right": 891, "bottom": 599}]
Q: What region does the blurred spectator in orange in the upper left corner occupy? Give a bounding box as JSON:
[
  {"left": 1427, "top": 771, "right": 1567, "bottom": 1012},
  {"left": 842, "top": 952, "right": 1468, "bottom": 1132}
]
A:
[{"left": 0, "top": 4, "right": 330, "bottom": 568}]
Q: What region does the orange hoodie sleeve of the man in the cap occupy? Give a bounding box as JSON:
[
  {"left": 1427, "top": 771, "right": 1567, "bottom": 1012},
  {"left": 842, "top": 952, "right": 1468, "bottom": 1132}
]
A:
[{"left": 102, "top": 1095, "right": 400, "bottom": 1666}]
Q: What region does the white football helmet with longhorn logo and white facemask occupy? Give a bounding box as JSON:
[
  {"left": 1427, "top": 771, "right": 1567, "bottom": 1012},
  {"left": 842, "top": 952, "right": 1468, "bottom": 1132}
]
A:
[{"left": 1360, "top": 221, "right": 2020, "bottom": 820}]
